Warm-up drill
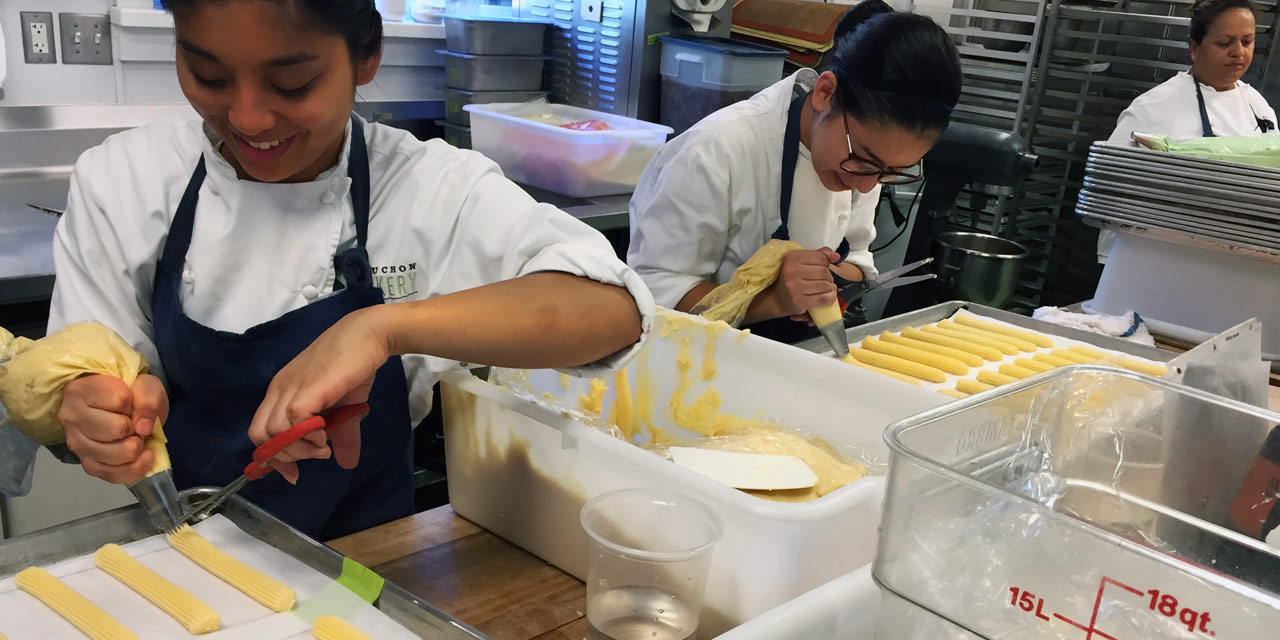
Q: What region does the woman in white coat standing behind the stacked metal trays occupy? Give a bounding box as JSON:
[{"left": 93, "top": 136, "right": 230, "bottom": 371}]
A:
[{"left": 1098, "top": 0, "right": 1277, "bottom": 262}]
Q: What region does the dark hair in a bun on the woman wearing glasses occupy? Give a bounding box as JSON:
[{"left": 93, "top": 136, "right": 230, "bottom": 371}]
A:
[{"left": 827, "top": 0, "right": 960, "bottom": 133}]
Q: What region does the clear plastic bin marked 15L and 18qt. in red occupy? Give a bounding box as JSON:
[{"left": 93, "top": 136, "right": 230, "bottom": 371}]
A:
[{"left": 874, "top": 366, "right": 1280, "bottom": 640}]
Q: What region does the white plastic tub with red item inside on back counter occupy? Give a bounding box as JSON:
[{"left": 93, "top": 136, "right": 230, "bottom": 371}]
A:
[{"left": 463, "top": 102, "right": 672, "bottom": 197}]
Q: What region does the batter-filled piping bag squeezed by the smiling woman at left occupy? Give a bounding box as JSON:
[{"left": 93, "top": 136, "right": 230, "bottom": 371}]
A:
[{"left": 0, "top": 323, "right": 182, "bottom": 531}]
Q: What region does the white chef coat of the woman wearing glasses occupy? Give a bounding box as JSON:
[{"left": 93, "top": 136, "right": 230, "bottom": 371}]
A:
[{"left": 627, "top": 69, "right": 881, "bottom": 307}]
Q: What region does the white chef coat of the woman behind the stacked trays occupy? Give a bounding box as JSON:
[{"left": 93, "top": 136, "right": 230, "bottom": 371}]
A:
[{"left": 1098, "top": 72, "right": 1280, "bottom": 264}]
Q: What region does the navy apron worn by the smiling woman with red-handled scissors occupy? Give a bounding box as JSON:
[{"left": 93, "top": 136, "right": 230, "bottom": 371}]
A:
[{"left": 151, "top": 119, "right": 413, "bottom": 540}]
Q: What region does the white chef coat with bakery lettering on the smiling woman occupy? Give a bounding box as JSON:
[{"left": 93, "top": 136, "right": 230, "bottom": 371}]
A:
[{"left": 49, "top": 118, "right": 654, "bottom": 424}]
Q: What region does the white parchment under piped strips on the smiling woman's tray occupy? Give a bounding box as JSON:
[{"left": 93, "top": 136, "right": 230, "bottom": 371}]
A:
[{"left": 0, "top": 516, "right": 417, "bottom": 640}]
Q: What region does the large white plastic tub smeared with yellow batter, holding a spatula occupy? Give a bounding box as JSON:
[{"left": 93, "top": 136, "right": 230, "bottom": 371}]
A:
[{"left": 443, "top": 309, "right": 950, "bottom": 637}]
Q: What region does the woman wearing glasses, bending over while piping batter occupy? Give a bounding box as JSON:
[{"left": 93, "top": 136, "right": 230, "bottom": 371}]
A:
[{"left": 627, "top": 0, "right": 960, "bottom": 342}]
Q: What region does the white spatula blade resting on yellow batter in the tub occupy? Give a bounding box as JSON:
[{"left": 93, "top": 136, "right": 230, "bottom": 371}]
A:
[{"left": 669, "top": 447, "right": 818, "bottom": 492}]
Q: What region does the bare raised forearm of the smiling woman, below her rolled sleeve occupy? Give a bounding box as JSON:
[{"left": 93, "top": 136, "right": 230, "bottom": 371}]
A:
[{"left": 379, "top": 271, "right": 641, "bottom": 369}]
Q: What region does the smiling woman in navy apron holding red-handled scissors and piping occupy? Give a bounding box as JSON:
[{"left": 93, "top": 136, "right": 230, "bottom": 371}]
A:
[{"left": 50, "top": 0, "right": 653, "bottom": 539}]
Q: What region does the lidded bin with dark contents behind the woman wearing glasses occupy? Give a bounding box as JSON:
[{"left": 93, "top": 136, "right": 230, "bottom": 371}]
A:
[{"left": 660, "top": 36, "right": 787, "bottom": 133}]
